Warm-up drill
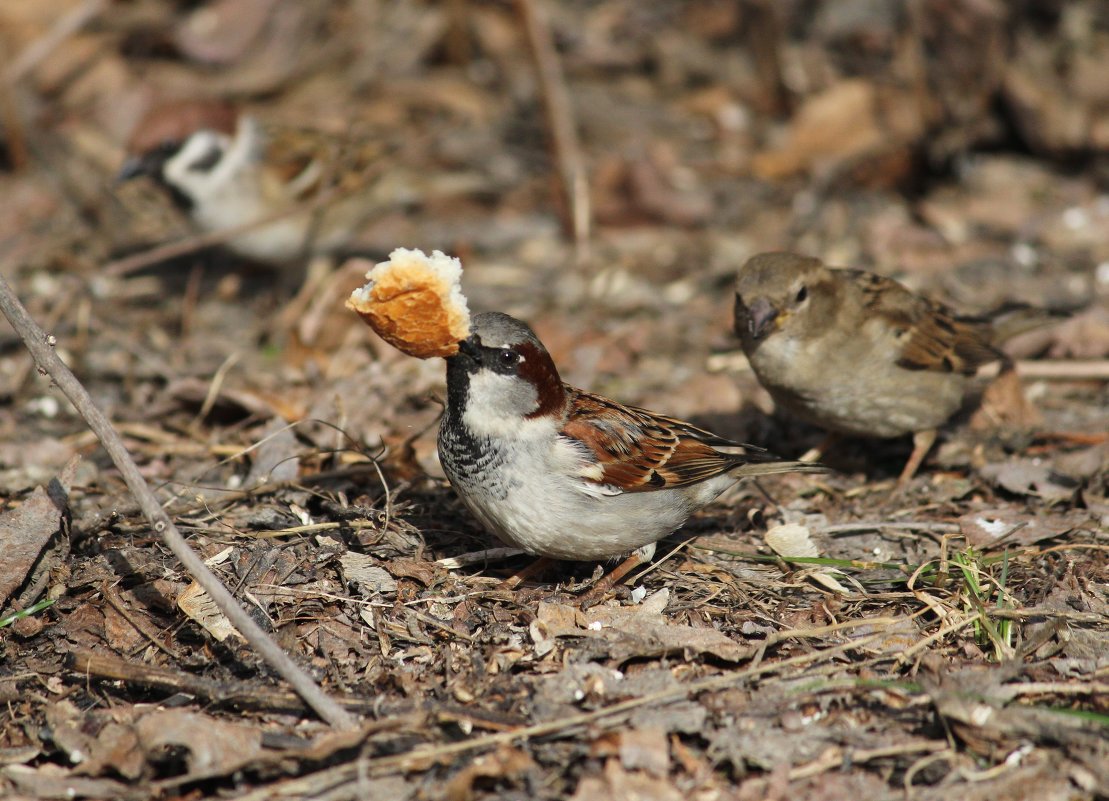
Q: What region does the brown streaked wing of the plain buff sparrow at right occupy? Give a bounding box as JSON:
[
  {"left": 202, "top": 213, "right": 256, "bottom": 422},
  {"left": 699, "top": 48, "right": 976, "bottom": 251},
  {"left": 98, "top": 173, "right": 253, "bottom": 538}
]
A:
[{"left": 844, "top": 270, "right": 1005, "bottom": 375}]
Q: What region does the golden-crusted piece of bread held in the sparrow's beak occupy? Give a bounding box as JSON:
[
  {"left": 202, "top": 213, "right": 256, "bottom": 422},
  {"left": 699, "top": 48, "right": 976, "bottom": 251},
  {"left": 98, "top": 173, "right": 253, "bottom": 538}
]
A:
[{"left": 346, "top": 242, "right": 470, "bottom": 358}]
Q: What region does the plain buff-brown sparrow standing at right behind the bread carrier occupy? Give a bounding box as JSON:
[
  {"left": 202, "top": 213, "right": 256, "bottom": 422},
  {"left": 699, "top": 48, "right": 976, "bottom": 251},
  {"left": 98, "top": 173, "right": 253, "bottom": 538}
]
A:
[{"left": 734, "top": 253, "right": 1046, "bottom": 485}]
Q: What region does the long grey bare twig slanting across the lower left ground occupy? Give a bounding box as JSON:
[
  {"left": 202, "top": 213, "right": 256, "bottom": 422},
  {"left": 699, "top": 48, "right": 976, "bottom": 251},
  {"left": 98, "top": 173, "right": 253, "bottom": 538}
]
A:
[{"left": 0, "top": 268, "right": 355, "bottom": 728}]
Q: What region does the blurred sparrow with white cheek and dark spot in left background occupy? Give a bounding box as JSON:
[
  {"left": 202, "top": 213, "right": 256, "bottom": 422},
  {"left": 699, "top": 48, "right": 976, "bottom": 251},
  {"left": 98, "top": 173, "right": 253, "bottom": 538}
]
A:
[{"left": 119, "top": 101, "right": 415, "bottom": 265}]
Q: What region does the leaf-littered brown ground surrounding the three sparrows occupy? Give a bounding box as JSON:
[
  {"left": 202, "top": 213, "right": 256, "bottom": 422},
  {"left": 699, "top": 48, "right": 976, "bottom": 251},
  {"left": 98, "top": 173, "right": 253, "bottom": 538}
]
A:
[{"left": 0, "top": 0, "right": 1109, "bottom": 801}]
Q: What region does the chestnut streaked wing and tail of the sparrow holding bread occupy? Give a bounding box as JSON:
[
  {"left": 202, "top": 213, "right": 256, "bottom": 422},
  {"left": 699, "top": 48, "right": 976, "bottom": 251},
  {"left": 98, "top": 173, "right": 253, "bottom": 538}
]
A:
[{"left": 561, "top": 386, "right": 823, "bottom": 493}]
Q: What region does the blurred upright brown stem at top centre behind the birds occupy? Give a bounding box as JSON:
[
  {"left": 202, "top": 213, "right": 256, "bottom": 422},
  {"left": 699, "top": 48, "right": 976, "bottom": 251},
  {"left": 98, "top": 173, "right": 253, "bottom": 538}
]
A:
[{"left": 516, "top": 0, "right": 592, "bottom": 264}]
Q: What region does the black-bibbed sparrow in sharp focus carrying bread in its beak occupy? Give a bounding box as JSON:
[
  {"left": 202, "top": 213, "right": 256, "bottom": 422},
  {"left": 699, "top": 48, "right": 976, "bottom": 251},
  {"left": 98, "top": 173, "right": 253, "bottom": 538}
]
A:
[{"left": 439, "top": 313, "right": 824, "bottom": 587}]
